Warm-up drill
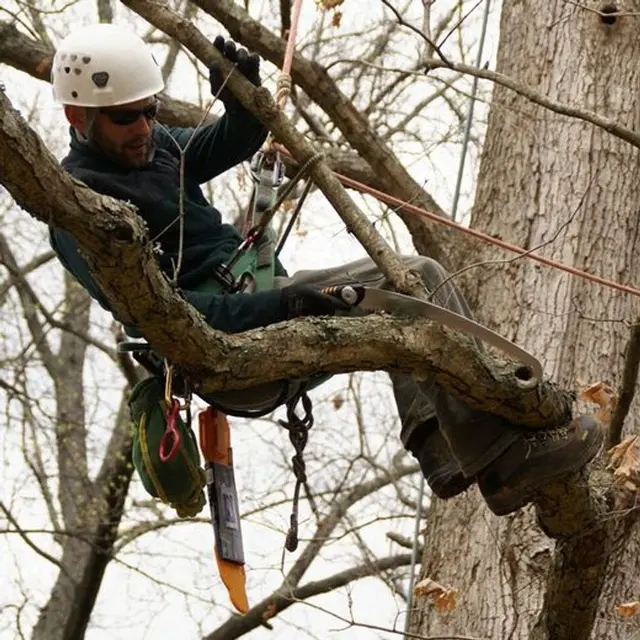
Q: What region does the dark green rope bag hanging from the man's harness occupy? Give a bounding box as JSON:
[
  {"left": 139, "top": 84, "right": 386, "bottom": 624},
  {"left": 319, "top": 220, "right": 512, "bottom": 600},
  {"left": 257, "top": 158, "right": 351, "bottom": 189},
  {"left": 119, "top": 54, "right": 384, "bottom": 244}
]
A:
[{"left": 129, "top": 376, "right": 205, "bottom": 518}]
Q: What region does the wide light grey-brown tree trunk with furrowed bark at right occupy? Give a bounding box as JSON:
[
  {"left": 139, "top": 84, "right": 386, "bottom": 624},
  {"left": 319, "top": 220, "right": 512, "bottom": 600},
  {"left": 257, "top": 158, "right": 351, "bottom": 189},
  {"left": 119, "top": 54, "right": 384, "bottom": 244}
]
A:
[{"left": 412, "top": 0, "right": 640, "bottom": 640}]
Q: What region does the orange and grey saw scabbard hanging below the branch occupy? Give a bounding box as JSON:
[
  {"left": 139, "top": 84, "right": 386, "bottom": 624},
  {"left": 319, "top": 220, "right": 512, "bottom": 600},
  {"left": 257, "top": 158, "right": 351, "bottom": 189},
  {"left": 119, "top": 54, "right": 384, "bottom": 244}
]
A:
[{"left": 198, "top": 407, "right": 249, "bottom": 613}]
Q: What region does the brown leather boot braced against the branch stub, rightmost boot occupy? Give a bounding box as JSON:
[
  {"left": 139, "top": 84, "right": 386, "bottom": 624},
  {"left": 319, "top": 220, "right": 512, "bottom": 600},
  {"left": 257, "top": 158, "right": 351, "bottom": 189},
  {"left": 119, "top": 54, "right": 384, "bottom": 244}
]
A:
[{"left": 478, "top": 415, "right": 604, "bottom": 516}]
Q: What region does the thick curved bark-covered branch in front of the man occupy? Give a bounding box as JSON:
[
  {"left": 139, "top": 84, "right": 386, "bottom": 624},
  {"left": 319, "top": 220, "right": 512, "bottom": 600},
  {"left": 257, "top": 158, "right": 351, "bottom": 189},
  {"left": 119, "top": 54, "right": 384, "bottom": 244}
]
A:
[{"left": 0, "top": 77, "right": 571, "bottom": 426}]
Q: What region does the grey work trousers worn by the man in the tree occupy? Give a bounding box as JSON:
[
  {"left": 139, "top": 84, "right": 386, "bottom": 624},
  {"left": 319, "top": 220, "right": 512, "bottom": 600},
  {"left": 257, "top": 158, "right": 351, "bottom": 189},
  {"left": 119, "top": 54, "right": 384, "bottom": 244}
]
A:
[{"left": 210, "top": 256, "right": 518, "bottom": 476}]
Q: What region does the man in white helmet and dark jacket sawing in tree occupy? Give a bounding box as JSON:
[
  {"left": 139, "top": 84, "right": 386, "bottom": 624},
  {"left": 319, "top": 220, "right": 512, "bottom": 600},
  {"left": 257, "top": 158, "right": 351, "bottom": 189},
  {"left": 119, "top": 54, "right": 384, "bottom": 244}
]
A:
[{"left": 51, "top": 24, "right": 602, "bottom": 515}]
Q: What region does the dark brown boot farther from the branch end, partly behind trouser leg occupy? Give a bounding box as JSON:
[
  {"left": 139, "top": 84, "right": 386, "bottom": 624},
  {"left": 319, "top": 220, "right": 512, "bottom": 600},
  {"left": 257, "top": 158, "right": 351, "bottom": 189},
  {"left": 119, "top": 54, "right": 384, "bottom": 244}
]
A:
[{"left": 406, "top": 418, "right": 475, "bottom": 500}]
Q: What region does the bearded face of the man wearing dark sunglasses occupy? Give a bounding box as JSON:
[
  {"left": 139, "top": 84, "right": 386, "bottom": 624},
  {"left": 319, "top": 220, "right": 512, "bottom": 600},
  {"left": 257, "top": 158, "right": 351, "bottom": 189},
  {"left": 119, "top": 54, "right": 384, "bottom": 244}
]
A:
[{"left": 91, "top": 97, "right": 157, "bottom": 169}]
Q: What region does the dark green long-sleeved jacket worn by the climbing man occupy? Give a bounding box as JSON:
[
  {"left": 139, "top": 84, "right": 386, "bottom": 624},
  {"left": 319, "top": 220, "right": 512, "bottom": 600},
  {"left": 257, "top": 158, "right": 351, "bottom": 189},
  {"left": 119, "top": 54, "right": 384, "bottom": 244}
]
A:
[{"left": 50, "top": 102, "right": 283, "bottom": 332}]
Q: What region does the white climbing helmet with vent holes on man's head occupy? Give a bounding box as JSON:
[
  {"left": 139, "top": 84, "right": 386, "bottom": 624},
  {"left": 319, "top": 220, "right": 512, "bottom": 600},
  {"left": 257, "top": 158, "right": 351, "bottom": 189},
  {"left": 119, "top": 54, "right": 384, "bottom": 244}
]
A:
[{"left": 51, "top": 24, "right": 164, "bottom": 107}]
